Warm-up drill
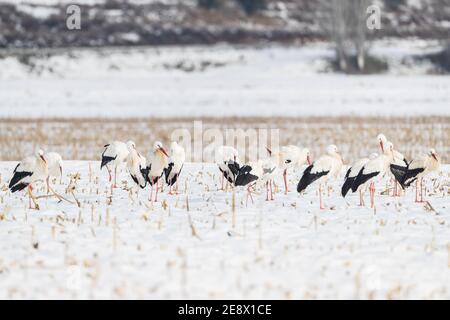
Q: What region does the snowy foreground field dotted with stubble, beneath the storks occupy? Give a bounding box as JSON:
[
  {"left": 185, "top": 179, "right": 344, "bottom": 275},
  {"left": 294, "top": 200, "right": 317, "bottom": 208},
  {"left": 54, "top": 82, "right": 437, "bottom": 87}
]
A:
[{"left": 0, "top": 161, "right": 450, "bottom": 299}]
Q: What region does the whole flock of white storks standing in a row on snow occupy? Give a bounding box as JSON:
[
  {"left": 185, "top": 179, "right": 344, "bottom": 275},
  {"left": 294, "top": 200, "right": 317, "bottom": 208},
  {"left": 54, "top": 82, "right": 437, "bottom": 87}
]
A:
[{"left": 9, "top": 134, "right": 440, "bottom": 209}]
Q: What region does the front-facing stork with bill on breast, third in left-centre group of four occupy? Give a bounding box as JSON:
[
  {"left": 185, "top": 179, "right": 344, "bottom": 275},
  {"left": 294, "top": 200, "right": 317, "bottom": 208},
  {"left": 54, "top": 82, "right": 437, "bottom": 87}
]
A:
[{"left": 145, "top": 141, "right": 169, "bottom": 202}]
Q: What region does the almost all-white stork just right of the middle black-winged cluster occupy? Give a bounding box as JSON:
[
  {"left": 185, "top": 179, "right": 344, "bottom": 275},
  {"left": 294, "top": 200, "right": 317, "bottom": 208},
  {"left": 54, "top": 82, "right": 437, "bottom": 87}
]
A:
[{"left": 266, "top": 145, "right": 311, "bottom": 194}]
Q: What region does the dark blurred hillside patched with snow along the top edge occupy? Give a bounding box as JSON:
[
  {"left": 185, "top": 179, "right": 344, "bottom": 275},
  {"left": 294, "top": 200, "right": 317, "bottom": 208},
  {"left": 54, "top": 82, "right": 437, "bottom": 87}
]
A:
[{"left": 0, "top": 0, "right": 450, "bottom": 48}]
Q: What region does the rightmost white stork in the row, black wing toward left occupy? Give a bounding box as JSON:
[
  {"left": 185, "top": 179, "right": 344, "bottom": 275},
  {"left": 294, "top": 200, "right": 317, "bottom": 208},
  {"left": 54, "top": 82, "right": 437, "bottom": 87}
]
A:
[{"left": 391, "top": 149, "right": 441, "bottom": 202}]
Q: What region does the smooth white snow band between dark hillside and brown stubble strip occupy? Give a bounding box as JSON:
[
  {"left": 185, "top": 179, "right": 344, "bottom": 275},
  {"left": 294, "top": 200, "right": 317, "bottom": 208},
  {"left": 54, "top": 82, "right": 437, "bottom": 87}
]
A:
[{"left": 0, "top": 42, "right": 450, "bottom": 117}]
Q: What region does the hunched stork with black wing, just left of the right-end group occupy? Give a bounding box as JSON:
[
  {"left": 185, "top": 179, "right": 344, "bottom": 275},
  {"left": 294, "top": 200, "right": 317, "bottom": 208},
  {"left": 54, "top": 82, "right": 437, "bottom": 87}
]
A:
[{"left": 297, "top": 145, "right": 343, "bottom": 209}]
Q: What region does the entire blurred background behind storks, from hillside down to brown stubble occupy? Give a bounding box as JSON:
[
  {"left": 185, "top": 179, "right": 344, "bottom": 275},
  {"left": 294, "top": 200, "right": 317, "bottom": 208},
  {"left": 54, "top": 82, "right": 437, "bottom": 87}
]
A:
[{"left": 0, "top": 0, "right": 450, "bottom": 162}]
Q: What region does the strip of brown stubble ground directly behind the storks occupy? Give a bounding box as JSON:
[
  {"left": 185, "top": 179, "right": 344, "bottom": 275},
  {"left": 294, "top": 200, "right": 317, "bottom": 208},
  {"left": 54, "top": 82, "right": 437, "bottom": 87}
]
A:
[{"left": 0, "top": 117, "right": 450, "bottom": 163}]
